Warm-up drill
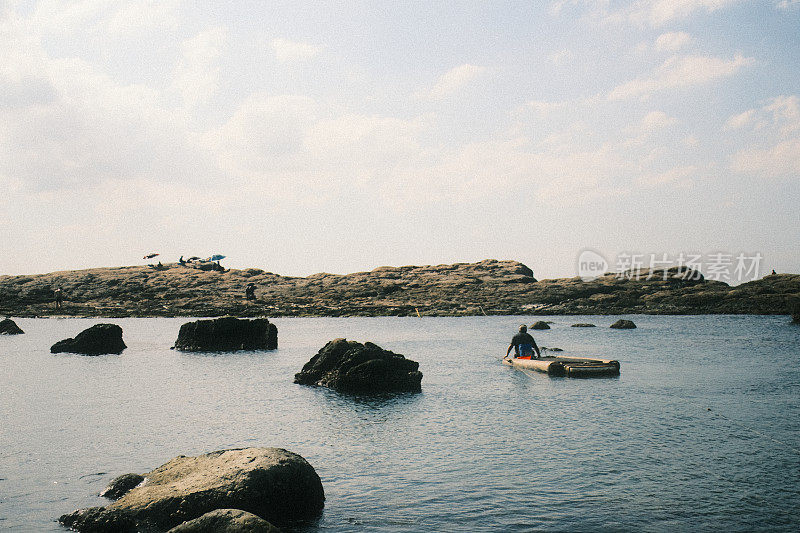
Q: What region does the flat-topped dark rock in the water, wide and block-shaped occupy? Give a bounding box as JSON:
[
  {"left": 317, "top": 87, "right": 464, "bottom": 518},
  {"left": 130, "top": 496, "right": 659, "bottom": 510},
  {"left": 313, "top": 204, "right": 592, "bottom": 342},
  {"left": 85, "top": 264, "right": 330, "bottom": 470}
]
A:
[{"left": 175, "top": 316, "right": 278, "bottom": 352}]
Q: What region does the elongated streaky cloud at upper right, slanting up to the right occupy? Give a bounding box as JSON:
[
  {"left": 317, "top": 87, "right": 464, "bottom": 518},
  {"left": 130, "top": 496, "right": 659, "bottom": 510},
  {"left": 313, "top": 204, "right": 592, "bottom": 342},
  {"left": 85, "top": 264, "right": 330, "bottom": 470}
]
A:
[{"left": 608, "top": 54, "right": 754, "bottom": 100}]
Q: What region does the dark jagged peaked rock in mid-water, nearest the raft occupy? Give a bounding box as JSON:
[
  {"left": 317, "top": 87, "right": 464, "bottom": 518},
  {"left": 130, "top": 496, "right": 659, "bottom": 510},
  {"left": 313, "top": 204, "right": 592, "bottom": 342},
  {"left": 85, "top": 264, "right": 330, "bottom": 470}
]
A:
[{"left": 294, "top": 339, "right": 422, "bottom": 393}]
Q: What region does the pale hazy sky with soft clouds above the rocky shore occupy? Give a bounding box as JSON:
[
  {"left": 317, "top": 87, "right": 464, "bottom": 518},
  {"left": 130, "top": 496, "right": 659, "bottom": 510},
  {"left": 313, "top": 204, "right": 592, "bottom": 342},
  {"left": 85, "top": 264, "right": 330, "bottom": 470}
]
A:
[{"left": 0, "top": 0, "right": 800, "bottom": 279}]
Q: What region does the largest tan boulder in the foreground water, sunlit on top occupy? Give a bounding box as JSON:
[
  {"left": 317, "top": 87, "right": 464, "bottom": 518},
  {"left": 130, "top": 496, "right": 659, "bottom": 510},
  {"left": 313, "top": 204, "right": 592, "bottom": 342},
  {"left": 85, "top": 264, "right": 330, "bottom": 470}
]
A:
[{"left": 58, "top": 448, "right": 325, "bottom": 533}]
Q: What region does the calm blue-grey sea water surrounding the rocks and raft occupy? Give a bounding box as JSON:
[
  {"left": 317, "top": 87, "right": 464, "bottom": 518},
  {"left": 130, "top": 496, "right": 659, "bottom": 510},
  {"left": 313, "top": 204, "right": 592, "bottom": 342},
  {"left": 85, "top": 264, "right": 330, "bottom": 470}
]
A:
[{"left": 0, "top": 316, "right": 800, "bottom": 532}]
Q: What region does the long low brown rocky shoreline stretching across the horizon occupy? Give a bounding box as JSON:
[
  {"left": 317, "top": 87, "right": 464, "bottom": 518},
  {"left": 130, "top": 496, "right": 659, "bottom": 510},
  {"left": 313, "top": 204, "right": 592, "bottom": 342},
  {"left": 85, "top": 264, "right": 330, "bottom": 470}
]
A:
[{"left": 0, "top": 259, "right": 800, "bottom": 318}]
